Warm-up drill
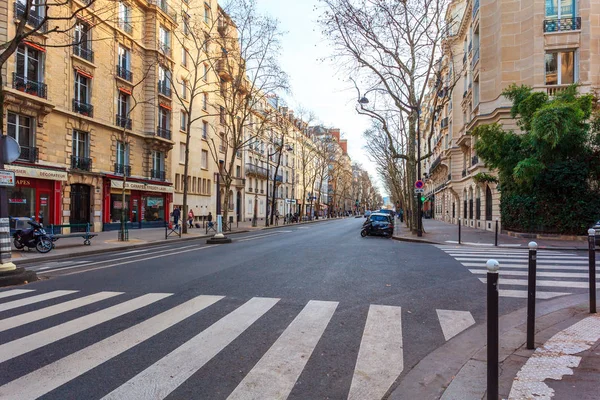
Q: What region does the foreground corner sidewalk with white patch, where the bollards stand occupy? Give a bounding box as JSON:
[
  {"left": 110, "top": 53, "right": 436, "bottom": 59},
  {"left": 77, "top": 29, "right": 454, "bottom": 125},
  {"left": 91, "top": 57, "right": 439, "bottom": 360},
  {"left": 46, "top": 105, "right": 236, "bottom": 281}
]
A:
[{"left": 389, "top": 295, "right": 600, "bottom": 400}]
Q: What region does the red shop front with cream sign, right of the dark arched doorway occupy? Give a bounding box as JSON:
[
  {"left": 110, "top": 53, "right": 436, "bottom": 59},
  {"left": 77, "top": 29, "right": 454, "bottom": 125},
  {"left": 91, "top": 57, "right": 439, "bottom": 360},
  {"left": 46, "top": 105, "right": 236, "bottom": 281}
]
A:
[{"left": 102, "top": 178, "right": 173, "bottom": 231}]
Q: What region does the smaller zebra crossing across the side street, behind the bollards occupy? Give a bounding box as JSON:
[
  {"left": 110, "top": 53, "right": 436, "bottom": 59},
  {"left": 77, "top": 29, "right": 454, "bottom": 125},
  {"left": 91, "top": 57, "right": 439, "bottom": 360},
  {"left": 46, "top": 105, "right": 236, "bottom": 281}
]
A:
[{"left": 437, "top": 245, "right": 589, "bottom": 299}]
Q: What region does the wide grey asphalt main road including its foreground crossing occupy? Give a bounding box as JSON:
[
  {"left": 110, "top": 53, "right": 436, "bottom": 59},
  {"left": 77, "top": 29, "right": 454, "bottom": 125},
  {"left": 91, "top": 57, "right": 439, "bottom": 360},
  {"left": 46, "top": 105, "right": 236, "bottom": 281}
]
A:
[{"left": 0, "top": 219, "right": 592, "bottom": 400}]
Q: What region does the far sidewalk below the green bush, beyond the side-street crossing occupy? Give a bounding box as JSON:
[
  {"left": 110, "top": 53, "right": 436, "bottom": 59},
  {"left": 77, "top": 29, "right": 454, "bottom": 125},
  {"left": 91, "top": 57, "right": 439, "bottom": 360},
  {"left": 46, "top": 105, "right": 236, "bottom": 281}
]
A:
[{"left": 394, "top": 219, "right": 588, "bottom": 250}]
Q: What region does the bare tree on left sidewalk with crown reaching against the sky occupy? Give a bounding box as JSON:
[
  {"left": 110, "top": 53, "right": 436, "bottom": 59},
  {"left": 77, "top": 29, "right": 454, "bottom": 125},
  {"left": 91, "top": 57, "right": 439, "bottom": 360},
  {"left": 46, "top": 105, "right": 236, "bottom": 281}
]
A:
[{"left": 209, "top": 0, "right": 288, "bottom": 225}]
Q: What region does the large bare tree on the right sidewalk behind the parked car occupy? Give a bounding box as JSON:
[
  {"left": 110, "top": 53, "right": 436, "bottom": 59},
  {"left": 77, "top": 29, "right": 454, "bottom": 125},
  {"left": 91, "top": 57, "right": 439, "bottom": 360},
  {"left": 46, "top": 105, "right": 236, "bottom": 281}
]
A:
[{"left": 320, "top": 0, "right": 460, "bottom": 233}]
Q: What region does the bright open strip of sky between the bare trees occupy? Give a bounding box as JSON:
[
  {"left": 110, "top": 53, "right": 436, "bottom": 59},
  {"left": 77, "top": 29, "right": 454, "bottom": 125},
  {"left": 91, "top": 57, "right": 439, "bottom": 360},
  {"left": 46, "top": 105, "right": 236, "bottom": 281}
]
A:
[{"left": 257, "top": 0, "right": 385, "bottom": 194}]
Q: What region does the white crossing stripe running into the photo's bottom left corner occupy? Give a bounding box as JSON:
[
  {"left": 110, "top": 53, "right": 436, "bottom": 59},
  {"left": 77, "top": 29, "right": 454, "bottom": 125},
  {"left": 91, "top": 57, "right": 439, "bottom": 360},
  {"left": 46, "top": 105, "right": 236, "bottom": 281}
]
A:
[{"left": 0, "top": 296, "right": 223, "bottom": 400}]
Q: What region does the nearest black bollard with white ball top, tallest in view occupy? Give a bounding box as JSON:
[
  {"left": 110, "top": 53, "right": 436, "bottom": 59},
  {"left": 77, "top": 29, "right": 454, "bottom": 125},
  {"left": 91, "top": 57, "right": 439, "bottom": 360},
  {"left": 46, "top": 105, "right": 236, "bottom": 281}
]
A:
[{"left": 486, "top": 260, "right": 500, "bottom": 400}]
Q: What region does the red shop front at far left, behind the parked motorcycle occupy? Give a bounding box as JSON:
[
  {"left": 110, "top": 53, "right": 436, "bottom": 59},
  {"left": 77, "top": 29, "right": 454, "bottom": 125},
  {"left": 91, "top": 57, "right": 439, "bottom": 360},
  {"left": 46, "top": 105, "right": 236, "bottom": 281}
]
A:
[{"left": 5, "top": 164, "right": 67, "bottom": 225}]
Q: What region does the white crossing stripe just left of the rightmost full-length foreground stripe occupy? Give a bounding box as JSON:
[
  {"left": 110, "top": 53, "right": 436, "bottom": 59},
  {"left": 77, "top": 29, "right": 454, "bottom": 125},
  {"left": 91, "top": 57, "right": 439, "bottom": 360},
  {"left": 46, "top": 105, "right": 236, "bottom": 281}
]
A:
[{"left": 227, "top": 300, "right": 338, "bottom": 400}]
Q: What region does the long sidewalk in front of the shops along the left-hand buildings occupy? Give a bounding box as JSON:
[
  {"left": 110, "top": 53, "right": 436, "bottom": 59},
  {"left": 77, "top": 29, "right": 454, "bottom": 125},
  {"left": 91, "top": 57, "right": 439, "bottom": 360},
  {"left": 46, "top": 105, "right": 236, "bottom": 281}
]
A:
[{"left": 11, "top": 218, "right": 340, "bottom": 265}]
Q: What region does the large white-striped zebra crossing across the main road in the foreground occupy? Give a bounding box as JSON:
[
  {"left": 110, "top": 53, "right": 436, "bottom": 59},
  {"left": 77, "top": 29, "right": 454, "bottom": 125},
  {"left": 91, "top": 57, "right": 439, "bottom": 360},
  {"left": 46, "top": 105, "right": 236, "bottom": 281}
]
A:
[{"left": 0, "top": 289, "right": 475, "bottom": 400}]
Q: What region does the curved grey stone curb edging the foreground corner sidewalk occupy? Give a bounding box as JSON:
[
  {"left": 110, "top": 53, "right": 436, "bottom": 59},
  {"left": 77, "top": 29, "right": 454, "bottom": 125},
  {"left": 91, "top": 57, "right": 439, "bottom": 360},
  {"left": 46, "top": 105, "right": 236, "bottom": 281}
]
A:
[{"left": 388, "top": 293, "right": 588, "bottom": 400}]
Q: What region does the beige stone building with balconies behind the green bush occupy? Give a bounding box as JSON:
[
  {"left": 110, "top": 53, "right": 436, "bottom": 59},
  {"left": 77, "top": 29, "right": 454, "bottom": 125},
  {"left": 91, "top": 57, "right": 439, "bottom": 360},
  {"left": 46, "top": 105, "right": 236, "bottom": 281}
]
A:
[{"left": 423, "top": 0, "right": 600, "bottom": 234}]
